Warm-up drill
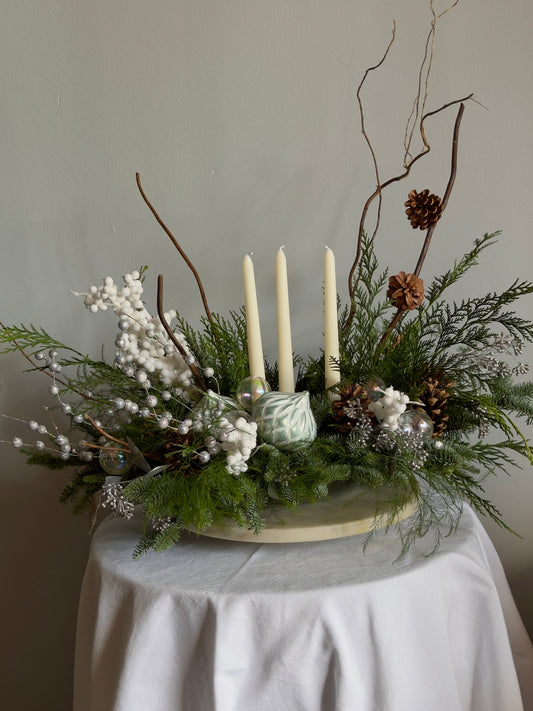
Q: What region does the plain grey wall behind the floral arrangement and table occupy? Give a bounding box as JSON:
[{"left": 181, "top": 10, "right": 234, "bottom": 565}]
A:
[{"left": 0, "top": 0, "right": 533, "bottom": 711}]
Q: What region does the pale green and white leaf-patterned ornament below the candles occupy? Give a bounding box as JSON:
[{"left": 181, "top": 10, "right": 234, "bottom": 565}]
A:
[{"left": 252, "top": 391, "right": 317, "bottom": 450}]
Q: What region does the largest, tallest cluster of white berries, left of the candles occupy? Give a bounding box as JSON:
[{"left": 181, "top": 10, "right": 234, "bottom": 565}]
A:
[{"left": 77, "top": 271, "right": 193, "bottom": 389}]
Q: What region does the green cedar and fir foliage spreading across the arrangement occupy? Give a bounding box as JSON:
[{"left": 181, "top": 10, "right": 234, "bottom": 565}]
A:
[{"left": 0, "top": 234, "right": 533, "bottom": 554}]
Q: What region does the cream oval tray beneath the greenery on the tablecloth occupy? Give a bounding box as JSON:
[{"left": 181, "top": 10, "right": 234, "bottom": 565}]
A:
[{"left": 185, "top": 487, "right": 417, "bottom": 543}]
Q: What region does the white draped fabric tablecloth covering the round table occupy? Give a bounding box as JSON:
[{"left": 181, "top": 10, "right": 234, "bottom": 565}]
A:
[{"left": 74, "top": 508, "right": 533, "bottom": 711}]
